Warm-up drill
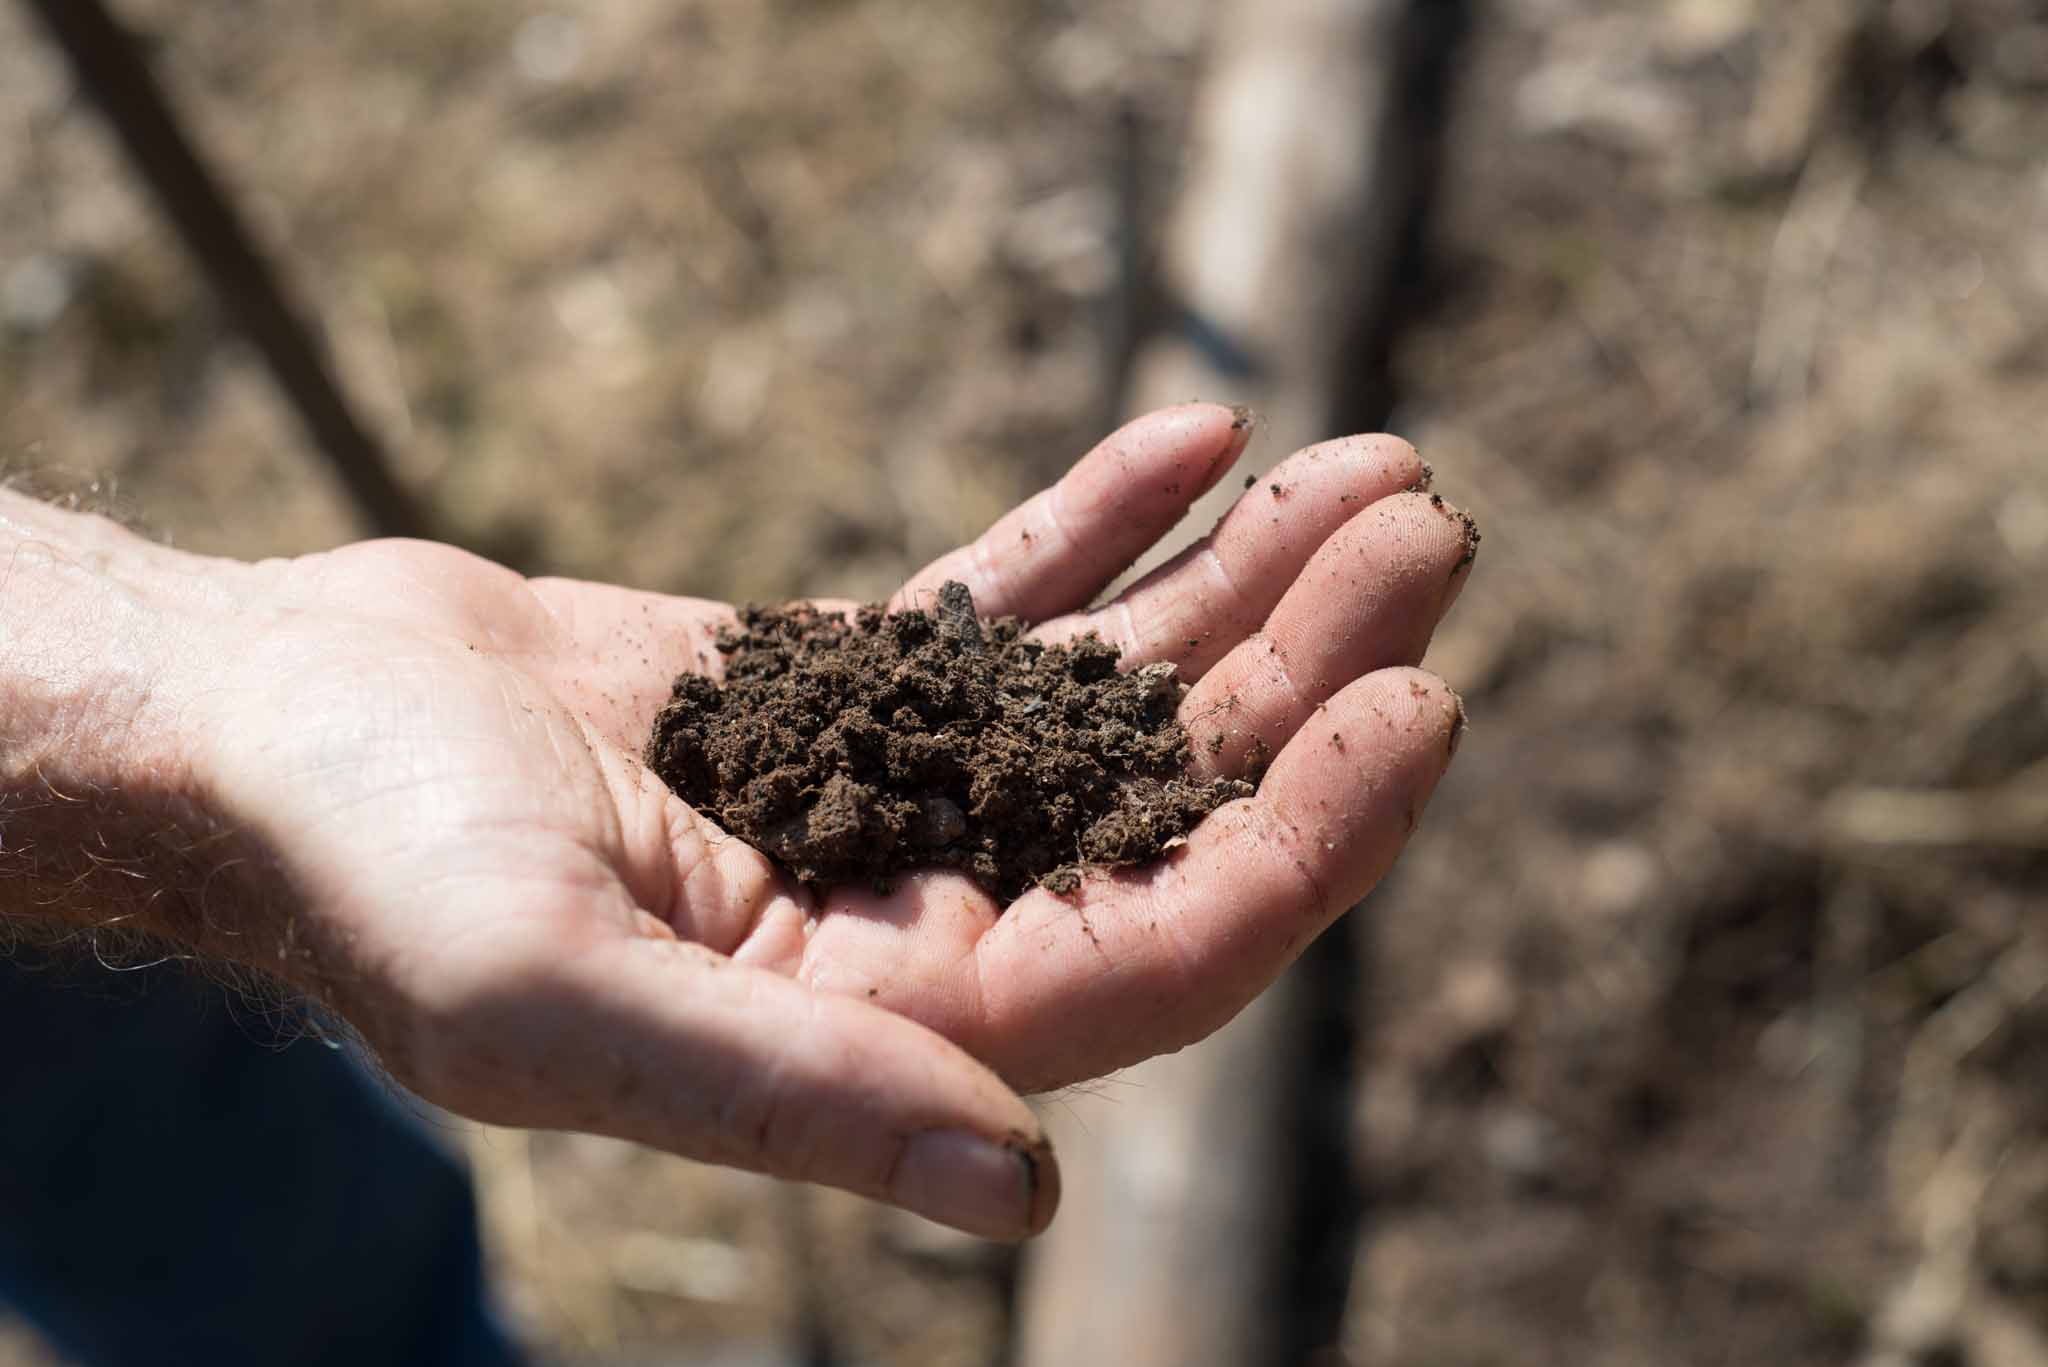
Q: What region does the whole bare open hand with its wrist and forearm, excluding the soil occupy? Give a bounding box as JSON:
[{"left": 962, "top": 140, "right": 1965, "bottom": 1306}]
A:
[{"left": 0, "top": 404, "right": 1470, "bottom": 1238}]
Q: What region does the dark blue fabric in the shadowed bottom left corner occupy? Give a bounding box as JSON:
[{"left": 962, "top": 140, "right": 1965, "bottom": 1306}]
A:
[{"left": 0, "top": 959, "right": 520, "bottom": 1367}]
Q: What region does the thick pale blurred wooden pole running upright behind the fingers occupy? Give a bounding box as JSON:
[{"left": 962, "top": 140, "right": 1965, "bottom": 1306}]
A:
[{"left": 1018, "top": 0, "right": 1470, "bottom": 1367}]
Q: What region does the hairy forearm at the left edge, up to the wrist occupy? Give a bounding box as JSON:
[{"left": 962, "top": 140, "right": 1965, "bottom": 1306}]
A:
[{"left": 0, "top": 490, "right": 270, "bottom": 957}]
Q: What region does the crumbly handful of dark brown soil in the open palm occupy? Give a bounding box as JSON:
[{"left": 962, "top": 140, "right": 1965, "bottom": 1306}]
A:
[{"left": 647, "top": 582, "right": 1251, "bottom": 902}]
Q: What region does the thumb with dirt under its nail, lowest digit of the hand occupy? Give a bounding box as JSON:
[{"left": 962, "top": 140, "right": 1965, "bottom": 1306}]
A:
[{"left": 406, "top": 937, "right": 1059, "bottom": 1240}]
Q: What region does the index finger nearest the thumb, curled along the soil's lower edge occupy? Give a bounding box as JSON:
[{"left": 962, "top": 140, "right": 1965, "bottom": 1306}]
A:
[{"left": 948, "top": 668, "right": 1464, "bottom": 1090}]
